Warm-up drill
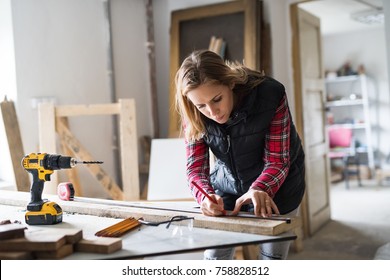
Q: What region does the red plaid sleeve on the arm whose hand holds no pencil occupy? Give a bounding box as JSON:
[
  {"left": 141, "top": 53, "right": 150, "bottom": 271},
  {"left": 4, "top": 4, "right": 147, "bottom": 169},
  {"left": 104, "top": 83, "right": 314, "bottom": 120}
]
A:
[{"left": 251, "top": 96, "right": 291, "bottom": 197}]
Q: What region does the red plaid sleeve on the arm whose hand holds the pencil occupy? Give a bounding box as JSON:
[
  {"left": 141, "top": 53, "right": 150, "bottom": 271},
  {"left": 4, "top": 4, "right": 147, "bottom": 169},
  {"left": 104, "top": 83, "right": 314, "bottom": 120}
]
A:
[{"left": 185, "top": 136, "right": 214, "bottom": 204}]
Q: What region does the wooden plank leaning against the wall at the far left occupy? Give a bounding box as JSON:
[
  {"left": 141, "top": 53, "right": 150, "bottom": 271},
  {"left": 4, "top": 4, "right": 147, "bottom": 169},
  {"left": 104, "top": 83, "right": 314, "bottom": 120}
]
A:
[{"left": 0, "top": 100, "right": 30, "bottom": 192}]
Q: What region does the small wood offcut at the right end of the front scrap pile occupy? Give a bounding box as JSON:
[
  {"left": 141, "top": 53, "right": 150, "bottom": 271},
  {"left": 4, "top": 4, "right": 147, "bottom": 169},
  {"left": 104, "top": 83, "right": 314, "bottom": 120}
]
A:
[{"left": 75, "top": 237, "right": 122, "bottom": 254}]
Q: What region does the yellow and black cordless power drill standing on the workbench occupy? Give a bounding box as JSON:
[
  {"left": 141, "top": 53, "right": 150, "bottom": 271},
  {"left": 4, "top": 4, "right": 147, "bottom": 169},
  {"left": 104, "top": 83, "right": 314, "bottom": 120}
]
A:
[{"left": 22, "top": 153, "right": 103, "bottom": 225}]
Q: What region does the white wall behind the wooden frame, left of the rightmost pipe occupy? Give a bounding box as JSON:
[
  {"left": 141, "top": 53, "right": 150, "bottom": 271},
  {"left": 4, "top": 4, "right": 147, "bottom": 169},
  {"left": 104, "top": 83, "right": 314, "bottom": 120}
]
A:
[{"left": 5, "top": 0, "right": 151, "bottom": 196}]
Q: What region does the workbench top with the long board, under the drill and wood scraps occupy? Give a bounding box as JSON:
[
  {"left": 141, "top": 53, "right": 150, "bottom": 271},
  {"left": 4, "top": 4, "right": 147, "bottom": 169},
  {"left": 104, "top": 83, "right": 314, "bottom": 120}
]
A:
[{"left": 0, "top": 191, "right": 300, "bottom": 260}]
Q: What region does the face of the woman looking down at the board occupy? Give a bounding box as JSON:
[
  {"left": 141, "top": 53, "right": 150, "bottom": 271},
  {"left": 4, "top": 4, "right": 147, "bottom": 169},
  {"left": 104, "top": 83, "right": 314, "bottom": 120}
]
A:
[{"left": 187, "top": 84, "right": 234, "bottom": 124}]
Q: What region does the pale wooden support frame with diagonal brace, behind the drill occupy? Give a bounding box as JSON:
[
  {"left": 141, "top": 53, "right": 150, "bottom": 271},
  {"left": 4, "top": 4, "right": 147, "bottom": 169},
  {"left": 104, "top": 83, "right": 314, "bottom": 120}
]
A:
[{"left": 38, "top": 99, "right": 140, "bottom": 200}]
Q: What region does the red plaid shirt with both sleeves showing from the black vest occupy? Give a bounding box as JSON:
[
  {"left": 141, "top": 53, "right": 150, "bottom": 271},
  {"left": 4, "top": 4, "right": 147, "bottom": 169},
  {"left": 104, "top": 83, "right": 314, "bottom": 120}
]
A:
[{"left": 185, "top": 96, "right": 291, "bottom": 204}]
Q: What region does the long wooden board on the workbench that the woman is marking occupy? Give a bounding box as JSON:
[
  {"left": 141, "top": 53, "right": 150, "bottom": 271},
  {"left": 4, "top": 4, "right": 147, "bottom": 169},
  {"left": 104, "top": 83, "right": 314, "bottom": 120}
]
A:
[{"left": 0, "top": 191, "right": 300, "bottom": 235}]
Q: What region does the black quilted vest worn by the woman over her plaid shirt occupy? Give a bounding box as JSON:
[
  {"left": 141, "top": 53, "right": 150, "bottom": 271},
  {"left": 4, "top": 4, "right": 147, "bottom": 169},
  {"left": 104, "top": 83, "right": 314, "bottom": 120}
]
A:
[{"left": 204, "top": 78, "right": 305, "bottom": 214}]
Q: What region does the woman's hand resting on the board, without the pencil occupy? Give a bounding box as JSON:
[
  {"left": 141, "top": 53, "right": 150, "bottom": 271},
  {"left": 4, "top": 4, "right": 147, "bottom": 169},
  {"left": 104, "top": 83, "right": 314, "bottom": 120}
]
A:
[{"left": 231, "top": 189, "right": 279, "bottom": 217}]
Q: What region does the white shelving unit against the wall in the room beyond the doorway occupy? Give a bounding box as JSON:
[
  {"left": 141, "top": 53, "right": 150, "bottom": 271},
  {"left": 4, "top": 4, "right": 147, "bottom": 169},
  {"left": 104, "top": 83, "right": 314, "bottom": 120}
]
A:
[{"left": 325, "top": 74, "right": 375, "bottom": 175}]
